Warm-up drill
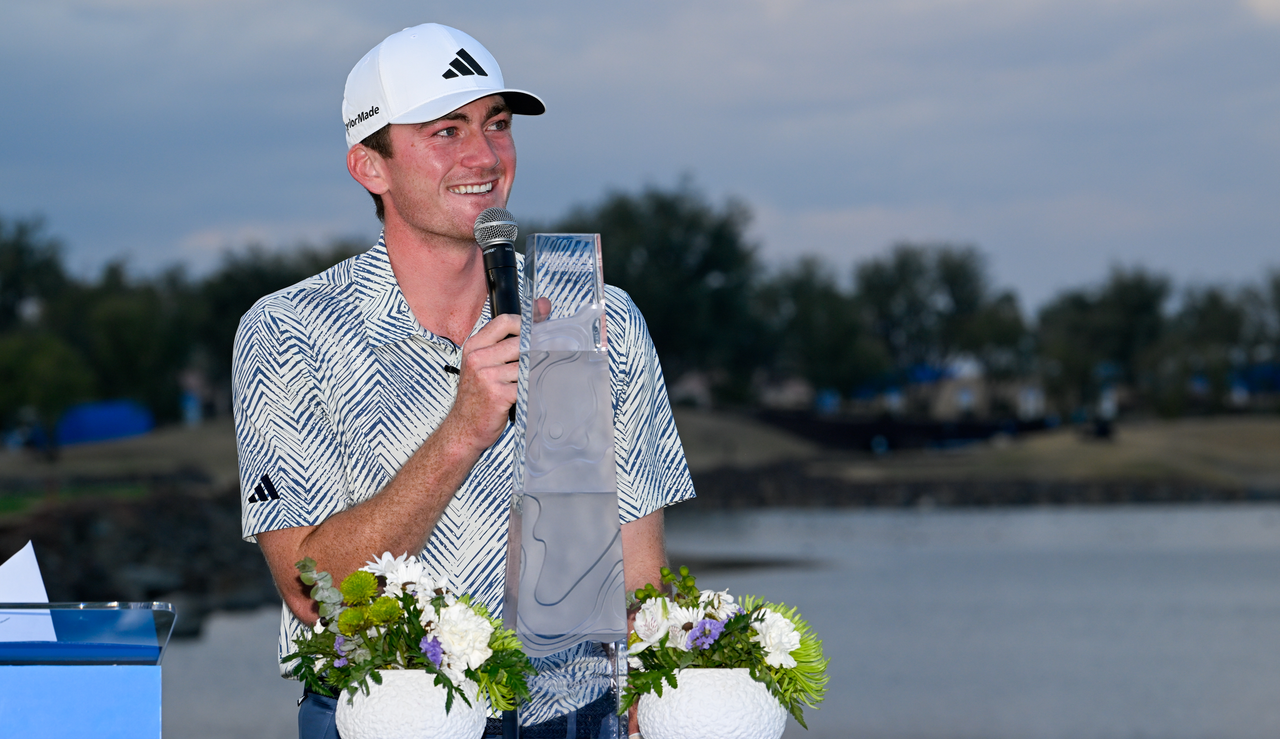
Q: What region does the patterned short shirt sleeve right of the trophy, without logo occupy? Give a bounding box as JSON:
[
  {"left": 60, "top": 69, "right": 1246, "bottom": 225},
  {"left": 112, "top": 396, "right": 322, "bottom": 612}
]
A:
[{"left": 605, "top": 286, "right": 694, "bottom": 523}]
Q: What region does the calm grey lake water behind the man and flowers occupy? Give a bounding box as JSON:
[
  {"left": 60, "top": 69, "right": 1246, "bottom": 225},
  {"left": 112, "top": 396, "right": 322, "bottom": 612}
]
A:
[{"left": 164, "top": 505, "right": 1280, "bottom": 739}]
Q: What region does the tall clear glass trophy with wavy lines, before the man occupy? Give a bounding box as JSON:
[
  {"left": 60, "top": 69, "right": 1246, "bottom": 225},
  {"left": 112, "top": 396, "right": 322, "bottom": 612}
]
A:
[{"left": 503, "top": 233, "right": 627, "bottom": 739}]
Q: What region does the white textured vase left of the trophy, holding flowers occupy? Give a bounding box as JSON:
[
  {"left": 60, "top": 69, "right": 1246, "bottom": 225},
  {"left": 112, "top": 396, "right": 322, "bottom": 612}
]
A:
[{"left": 337, "top": 670, "right": 489, "bottom": 739}]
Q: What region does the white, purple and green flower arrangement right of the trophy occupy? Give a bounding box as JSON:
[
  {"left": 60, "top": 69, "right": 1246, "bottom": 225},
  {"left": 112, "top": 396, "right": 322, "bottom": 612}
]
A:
[{"left": 621, "top": 567, "right": 827, "bottom": 729}]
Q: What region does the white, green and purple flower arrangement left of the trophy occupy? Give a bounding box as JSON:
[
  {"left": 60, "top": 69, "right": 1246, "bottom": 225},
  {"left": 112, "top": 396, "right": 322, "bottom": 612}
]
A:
[{"left": 284, "top": 552, "right": 536, "bottom": 711}]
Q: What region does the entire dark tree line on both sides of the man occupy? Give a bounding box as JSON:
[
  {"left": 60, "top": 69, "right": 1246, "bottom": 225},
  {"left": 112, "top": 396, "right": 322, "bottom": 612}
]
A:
[{"left": 0, "top": 182, "right": 1280, "bottom": 440}]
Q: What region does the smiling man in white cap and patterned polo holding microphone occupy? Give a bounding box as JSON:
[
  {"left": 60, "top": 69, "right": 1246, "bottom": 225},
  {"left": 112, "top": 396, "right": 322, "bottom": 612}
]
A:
[{"left": 233, "top": 24, "right": 692, "bottom": 736}]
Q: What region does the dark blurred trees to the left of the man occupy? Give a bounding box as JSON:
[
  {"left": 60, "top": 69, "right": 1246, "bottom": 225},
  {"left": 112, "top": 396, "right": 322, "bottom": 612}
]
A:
[{"left": 0, "top": 219, "right": 365, "bottom": 440}]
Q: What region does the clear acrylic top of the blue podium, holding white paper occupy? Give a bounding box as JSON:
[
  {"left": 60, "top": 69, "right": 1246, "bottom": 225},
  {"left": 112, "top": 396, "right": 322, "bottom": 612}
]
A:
[{"left": 0, "top": 602, "right": 177, "bottom": 665}]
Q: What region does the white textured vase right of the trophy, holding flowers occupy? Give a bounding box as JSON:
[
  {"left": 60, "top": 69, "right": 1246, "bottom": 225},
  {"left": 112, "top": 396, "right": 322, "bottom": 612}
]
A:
[{"left": 637, "top": 667, "right": 787, "bottom": 739}]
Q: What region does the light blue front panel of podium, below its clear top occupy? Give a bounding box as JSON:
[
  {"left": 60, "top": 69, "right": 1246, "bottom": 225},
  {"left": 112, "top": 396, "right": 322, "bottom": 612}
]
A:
[{"left": 0, "top": 665, "right": 160, "bottom": 739}]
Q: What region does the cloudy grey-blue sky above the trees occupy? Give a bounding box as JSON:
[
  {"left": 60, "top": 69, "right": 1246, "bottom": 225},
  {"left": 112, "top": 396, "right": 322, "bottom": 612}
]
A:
[{"left": 0, "top": 0, "right": 1280, "bottom": 309}]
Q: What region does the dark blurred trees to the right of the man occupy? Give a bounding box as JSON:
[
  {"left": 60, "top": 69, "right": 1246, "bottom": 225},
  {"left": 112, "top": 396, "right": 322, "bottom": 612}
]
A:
[{"left": 552, "top": 184, "right": 1280, "bottom": 416}]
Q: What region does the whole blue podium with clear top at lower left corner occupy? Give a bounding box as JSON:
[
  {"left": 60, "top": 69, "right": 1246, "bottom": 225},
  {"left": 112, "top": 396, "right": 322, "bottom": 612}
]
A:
[{"left": 0, "top": 602, "right": 175, "bottom": 739}]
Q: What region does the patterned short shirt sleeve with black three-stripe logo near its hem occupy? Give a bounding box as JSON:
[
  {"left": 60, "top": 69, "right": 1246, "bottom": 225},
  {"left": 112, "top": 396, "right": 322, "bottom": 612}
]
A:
[{"left": 232, "top": 296, "right": 347, "bottom": 542}]
